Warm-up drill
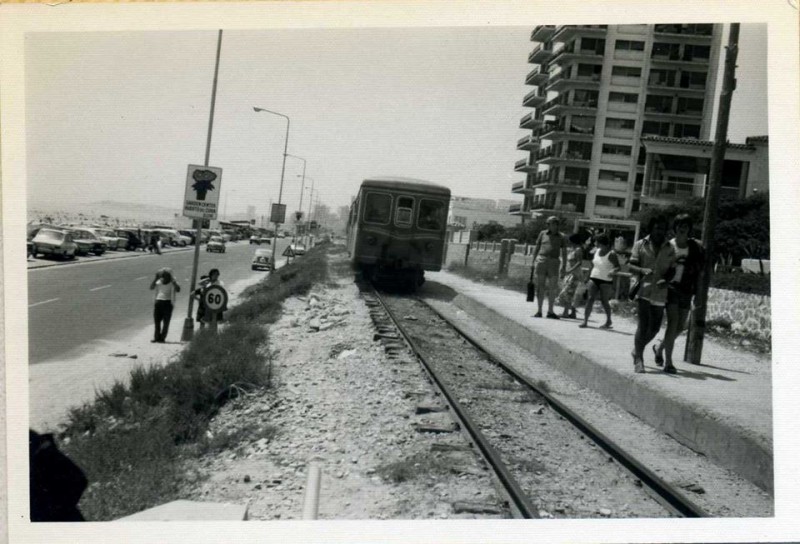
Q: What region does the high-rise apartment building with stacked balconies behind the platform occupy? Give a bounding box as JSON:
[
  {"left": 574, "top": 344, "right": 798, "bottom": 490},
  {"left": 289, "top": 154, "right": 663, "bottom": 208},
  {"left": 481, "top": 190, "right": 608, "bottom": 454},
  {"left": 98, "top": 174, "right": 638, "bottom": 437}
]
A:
[{"left": 509, "top": 24, "right": 722, "bottom": 221}]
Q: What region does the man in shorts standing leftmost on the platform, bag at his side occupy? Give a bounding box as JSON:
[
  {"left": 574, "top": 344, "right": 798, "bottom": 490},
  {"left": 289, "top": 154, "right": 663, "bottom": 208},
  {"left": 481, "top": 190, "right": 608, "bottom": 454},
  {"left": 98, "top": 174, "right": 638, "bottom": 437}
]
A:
[{"left": 533, "top": 216, "right": 567, "bottom": 319}]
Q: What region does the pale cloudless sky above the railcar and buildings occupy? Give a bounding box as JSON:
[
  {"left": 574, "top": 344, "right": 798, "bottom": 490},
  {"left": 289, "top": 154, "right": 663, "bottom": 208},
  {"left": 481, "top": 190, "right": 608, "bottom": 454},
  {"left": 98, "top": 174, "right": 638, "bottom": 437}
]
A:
[{"left": 25, "top": 24, "right": 767, "bottom": 216}]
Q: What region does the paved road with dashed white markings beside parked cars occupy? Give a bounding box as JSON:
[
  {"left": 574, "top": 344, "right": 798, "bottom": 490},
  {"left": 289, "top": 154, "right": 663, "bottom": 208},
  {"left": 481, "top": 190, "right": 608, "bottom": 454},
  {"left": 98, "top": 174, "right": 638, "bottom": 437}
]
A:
[{"left": 28, "top": 239, "right": 290, "bottom": 364}]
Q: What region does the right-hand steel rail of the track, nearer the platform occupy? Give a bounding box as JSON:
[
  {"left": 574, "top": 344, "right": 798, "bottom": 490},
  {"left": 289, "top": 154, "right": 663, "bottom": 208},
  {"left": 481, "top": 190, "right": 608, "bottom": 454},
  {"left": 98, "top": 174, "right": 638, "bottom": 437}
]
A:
[{"left": 417, "top": 297, "right": 710, "bottom": 518}]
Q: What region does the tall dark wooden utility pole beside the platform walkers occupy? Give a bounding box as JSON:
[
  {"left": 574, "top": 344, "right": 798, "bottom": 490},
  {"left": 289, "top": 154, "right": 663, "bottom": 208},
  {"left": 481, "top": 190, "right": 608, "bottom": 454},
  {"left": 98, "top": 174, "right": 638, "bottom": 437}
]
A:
[{"left": 687, "top": 23, "right": 739, "bottom": 365}]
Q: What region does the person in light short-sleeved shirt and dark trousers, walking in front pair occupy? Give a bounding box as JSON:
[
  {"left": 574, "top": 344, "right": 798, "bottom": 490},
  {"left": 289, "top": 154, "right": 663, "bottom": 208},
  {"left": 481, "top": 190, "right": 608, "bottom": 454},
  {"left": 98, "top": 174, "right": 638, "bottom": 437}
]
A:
[{"left": 628, "top": 215, "right": 675, "bottom": 374}]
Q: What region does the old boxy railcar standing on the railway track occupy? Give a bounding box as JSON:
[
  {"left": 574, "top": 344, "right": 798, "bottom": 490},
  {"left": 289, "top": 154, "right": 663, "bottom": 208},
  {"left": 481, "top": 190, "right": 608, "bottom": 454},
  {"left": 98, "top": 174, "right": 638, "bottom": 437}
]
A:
[{"left": 347, "top": 176, "right": 450, "bottom": 289}]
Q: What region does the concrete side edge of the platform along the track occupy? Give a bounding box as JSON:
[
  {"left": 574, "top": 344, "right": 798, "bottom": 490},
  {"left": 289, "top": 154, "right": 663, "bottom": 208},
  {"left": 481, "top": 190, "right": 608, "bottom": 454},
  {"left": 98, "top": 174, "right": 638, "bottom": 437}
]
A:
[{"left": 452, "top": 294, "right": 774, "bottom": 494}]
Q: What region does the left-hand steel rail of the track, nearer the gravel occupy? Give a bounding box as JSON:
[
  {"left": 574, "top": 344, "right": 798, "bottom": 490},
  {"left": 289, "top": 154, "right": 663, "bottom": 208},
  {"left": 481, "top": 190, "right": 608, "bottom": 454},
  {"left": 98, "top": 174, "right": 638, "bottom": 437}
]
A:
[{"left": 373, "top": 289, "right": 540, "bottom": 519}]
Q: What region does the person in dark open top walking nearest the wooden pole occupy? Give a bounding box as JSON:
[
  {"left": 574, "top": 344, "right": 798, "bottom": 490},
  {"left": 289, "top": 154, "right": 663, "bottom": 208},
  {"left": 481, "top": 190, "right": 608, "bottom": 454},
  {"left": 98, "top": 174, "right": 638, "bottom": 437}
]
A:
[{"left": 653, "top": 213, "right": 705, "bottom": 374}]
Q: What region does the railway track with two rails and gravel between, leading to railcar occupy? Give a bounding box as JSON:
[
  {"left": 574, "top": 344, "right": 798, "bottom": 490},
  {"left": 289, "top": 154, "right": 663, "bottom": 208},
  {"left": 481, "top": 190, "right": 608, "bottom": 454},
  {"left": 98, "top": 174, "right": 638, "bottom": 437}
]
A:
[{"left": 360, "top": 284, "right": 708, "bottom": 518}]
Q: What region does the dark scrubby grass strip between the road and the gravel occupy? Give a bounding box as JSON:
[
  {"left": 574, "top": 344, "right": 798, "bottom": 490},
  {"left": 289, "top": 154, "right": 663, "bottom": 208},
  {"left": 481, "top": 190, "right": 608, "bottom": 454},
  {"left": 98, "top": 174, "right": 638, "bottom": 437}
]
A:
[{"left": 60, "top": 244, "right": 328, "bottom": 521}]
